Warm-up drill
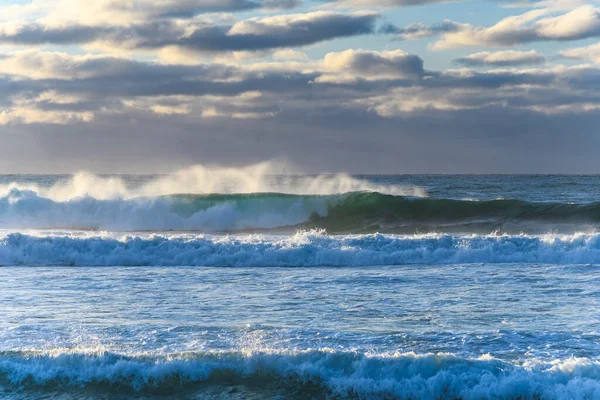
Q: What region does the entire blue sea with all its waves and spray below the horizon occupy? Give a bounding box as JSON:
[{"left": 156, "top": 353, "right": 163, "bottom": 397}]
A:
[{"left": 0, "top": 165, "right": 600, "bottom": 400}]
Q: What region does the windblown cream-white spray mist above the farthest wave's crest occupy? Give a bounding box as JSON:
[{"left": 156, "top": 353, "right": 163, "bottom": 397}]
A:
[{"left": 0, "top": 162, "right": 427, "bottom": 202}]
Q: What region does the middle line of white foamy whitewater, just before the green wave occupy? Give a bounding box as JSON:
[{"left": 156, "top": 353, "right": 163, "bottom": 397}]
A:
[{"left": 0, "top": 231, "right": 600, "bottom": 267}]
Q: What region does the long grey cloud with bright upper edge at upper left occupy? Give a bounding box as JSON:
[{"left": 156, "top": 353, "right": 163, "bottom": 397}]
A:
[{"left": 0, "top": 11, "right": 379, "bottom": 53}]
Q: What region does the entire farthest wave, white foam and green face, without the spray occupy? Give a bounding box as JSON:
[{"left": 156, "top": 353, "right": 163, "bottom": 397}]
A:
[{"left": 0, "top": 189, "right": 600, "bottom": 233}]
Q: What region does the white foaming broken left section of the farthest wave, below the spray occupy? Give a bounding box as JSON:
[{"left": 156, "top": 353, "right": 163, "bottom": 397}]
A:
[{"left": 0, "top": 189, "right": 335, "bottom": 232}]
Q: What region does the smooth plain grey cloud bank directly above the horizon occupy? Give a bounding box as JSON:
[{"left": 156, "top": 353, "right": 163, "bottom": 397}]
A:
[{"left": 0, "top": 108, "right": 600, "bottom": 174}]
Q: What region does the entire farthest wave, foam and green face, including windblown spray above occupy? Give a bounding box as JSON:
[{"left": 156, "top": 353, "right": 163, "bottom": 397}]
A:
[{"left": 0, "top": 163, "right": 600, "bottom": 233}]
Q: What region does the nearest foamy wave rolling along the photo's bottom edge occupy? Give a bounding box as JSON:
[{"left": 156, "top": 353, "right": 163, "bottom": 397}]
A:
[{"left": 0, "top": 349, "right": 600, "bottom": 399}]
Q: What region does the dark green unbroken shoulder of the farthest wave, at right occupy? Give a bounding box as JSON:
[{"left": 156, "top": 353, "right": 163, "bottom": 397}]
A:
[{"left": 313, "top": 192, "right": 600, "bottom": 232}]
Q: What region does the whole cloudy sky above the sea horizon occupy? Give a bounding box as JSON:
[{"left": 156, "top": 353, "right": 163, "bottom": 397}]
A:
[{"left": 0, "top": 0, "right": 600, "bottom": 174}]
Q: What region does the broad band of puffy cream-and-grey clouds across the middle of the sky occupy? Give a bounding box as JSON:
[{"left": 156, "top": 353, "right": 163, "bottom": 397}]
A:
[{"left": 0, "top": 49, "right": 600, "bottom": 124}]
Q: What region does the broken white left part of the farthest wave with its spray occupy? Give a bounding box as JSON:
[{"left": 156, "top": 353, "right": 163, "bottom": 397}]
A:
[{"left": 0, "top": 163, "right": 425, "bottom": 232}]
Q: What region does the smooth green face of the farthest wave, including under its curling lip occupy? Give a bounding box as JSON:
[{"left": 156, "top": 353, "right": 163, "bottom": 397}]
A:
[{"left": 162, "top": 192, "right": 600, "bottom": 233}]
